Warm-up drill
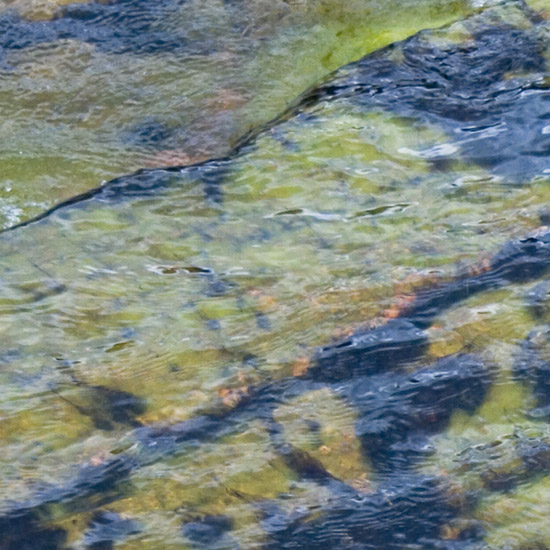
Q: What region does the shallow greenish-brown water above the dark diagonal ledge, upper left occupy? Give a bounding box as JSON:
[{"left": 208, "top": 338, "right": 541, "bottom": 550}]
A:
[{"left": 0, "top": 0, "right": 465, "bottom": 226}]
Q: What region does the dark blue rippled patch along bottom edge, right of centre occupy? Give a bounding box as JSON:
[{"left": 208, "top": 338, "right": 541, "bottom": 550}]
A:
[{"left": 264, "top": 475, "right": 476, "bottom": 550}]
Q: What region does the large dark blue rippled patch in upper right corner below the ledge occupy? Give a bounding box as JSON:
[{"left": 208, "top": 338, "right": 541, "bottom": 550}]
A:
[{"left": 304, "top": 2, "right": 550, "bottom": 183}]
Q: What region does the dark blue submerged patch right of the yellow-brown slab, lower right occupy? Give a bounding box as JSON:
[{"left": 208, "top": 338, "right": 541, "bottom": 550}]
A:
[{"left": 348, "top": 355, "right": 491, "bottom": 472}]
